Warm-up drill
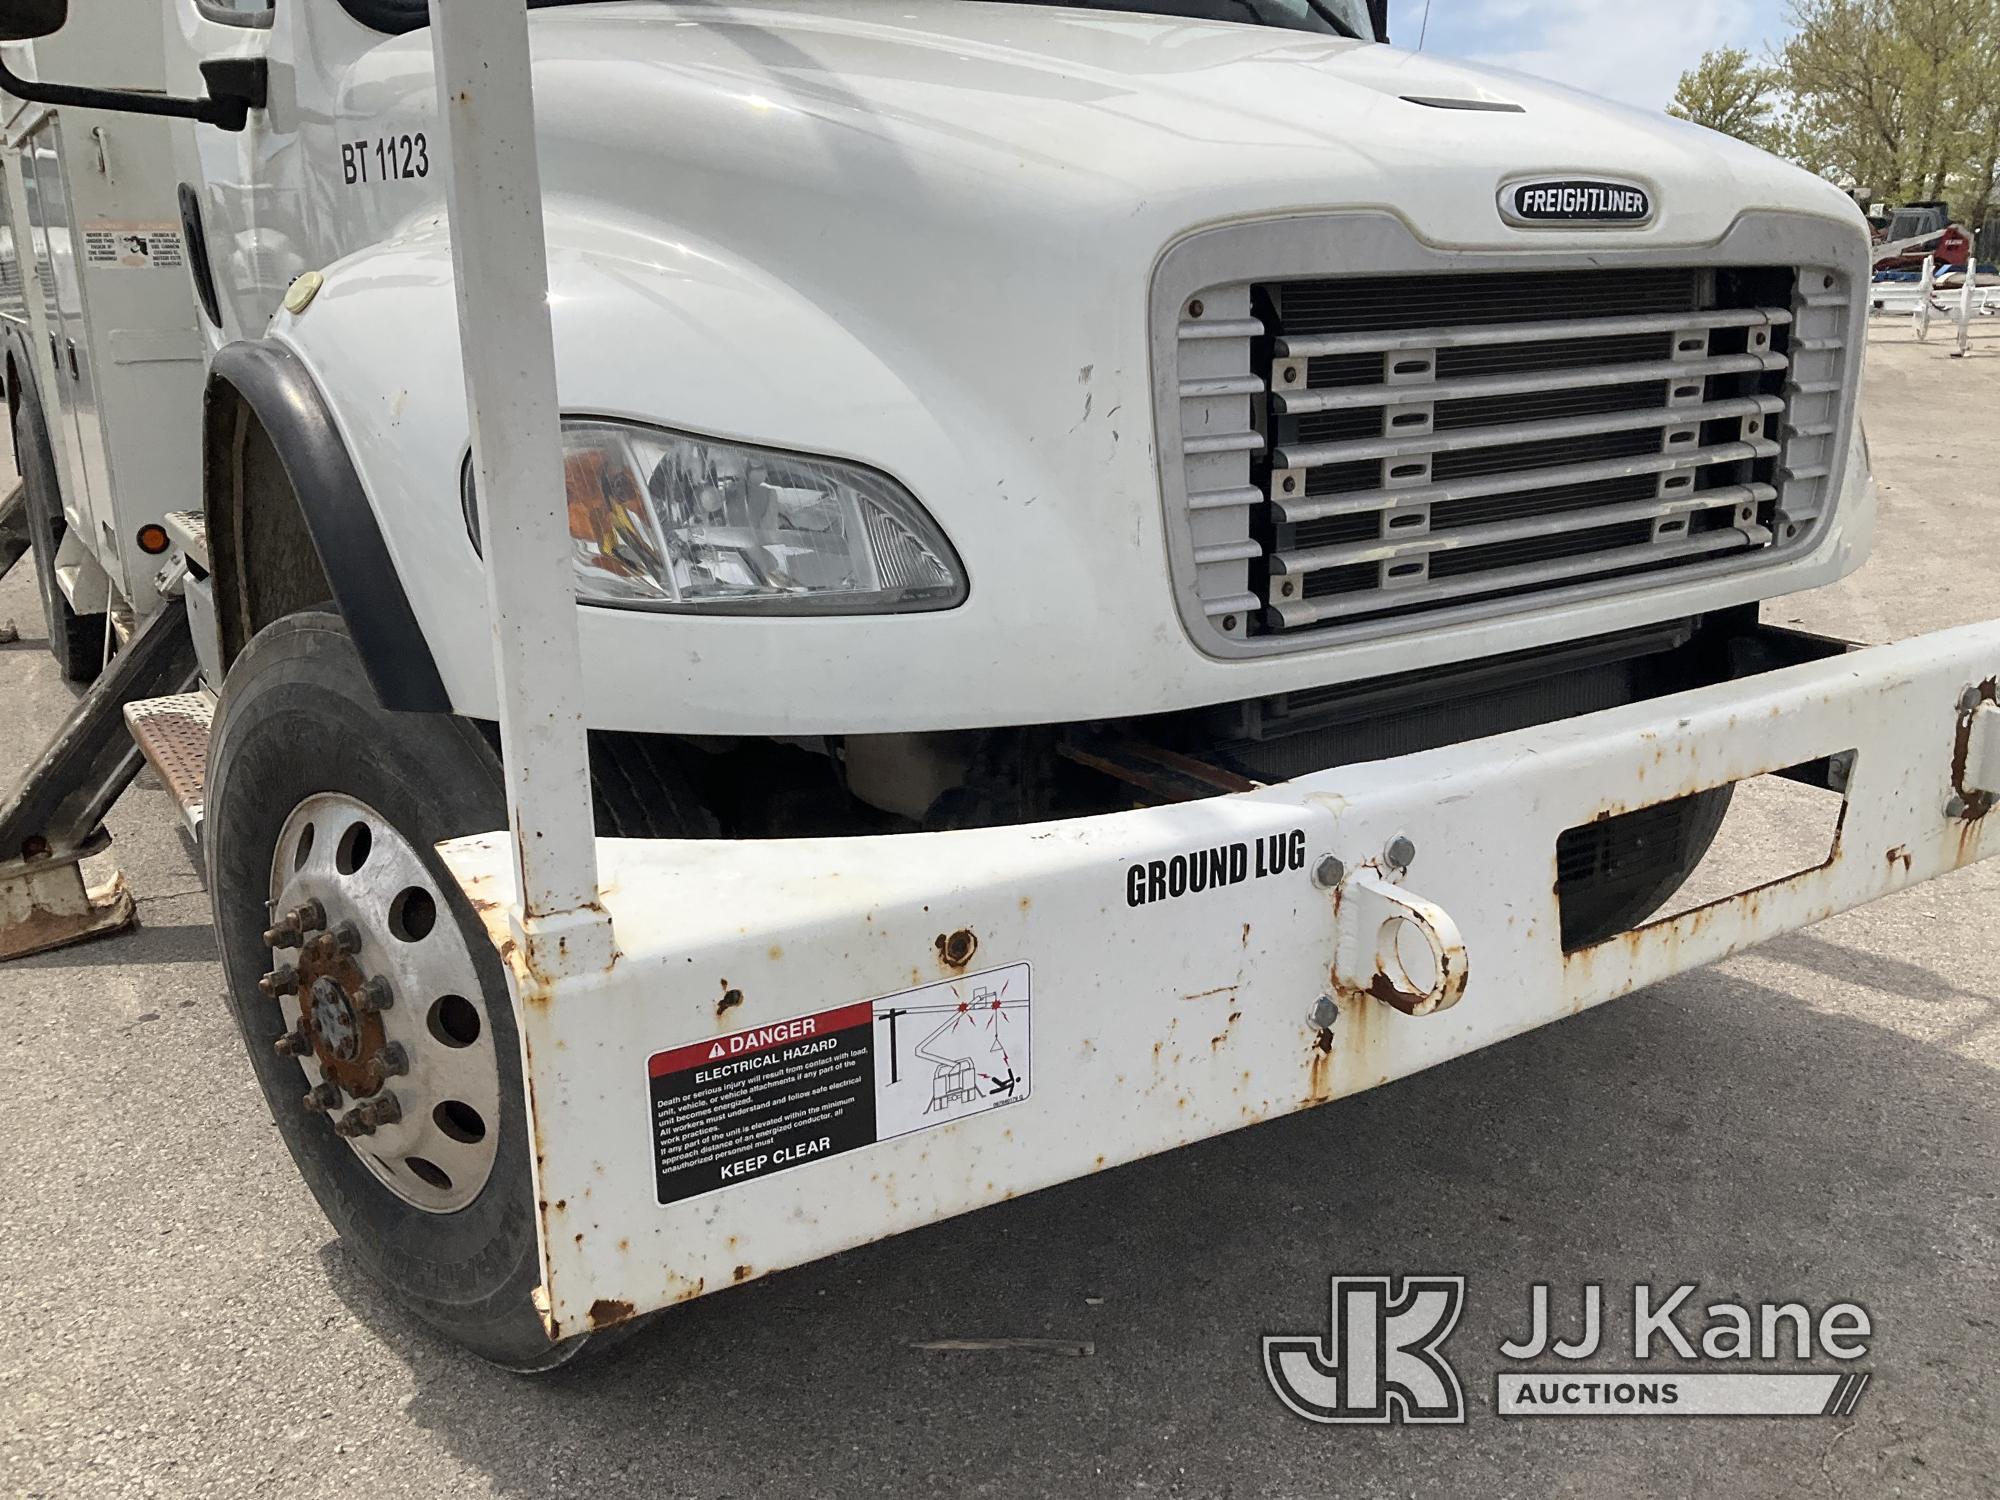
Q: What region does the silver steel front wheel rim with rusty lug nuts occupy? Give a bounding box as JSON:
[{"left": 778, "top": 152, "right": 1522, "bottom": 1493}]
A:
[{"left": 266, "top": 792, "right": 500, "bottom": 1214}]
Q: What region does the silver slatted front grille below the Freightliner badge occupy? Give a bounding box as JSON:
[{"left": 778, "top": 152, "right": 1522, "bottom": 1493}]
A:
[{"left": 1176, "top": 266, "right": 1846, "bottom": 644}]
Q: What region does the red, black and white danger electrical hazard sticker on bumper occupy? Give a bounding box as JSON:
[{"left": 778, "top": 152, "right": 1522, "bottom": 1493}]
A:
[{"left": 646, "top": 964, "right": 1032, "bottom": 1204}]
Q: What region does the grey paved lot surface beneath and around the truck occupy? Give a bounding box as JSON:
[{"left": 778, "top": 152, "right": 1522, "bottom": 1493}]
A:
[{"left": 0, "top": 322, "right": 2000, "bottom": 1500}]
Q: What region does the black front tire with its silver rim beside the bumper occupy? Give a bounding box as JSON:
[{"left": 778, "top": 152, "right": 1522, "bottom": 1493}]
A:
[{"left": 204, "top": 612, "right": 584, "bottom": 1370}]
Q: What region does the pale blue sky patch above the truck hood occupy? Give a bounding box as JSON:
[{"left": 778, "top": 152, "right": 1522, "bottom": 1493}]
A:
[{"left": 1416, "top": 0, "right": 1786, "bottom": 110}]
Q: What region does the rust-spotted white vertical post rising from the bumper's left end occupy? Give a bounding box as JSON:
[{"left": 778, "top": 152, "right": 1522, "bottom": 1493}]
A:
[{"left": 430, "top": 0, "right": 612, "bottom": 978}]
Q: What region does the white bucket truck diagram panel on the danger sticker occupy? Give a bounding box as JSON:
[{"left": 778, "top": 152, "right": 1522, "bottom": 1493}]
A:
[{"left": 874, "top": 964, "right": 1030, "bottom": 1140}]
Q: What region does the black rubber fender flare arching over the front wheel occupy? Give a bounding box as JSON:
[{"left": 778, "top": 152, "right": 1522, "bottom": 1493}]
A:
[{"left": 202, "top": 338, "right": 452, "bottom": 714}]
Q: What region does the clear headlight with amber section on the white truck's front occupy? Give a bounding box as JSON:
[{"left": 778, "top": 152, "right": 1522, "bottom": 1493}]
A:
[{"left": 464, "top": 418, "right": 966, "bottom": 614}]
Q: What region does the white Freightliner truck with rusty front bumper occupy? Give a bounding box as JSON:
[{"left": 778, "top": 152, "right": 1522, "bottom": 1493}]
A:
[{"left": 0, "top": 0, "right": 2000, "bottom": 1368}]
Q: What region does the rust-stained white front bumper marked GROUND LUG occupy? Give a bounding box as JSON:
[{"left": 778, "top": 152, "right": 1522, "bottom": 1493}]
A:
[{"left": 444, "top": 622, "right": 2000, "bottom": 1336}]
